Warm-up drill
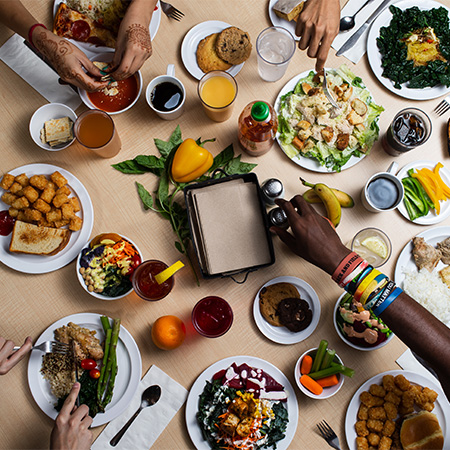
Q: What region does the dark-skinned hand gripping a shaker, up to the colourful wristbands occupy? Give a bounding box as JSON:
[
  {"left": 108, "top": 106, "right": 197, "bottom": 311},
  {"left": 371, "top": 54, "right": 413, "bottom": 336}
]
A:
[{"left": 271, "top": 195, "right": 350, "bottom": 275}]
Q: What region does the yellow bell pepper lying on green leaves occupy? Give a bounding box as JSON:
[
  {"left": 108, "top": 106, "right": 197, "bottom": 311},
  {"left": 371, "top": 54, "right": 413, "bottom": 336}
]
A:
[{"left": 172, "top": 139, "right": 214, "bottom": 183}]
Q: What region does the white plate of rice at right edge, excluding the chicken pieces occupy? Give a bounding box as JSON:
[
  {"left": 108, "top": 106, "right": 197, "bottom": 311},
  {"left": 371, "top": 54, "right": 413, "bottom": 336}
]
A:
[{"left": 394, "top": 227, "right": 450, "bottom": 328}]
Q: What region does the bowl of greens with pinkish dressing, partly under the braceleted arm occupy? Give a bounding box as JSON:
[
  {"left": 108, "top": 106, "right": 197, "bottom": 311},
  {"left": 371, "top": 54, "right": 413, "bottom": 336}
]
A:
[{"left": 333, "top": 292, "right": 394, "bottom": 352}]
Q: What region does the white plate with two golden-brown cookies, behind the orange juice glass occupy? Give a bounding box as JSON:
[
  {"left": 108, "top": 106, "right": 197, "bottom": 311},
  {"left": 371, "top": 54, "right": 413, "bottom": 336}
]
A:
[{"left": 181, "top": 20, "right": 252, "bottom": 80}]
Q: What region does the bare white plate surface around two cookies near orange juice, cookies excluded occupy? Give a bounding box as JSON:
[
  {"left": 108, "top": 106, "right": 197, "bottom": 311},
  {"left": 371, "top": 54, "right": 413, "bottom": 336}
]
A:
[{"left": 181, "top": 20, "right": 244, "bottom": 80}]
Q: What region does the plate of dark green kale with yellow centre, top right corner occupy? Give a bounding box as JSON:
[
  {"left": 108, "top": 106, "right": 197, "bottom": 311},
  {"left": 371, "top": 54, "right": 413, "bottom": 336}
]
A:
[{"left": 367, "top": 0, "right": 450, "bottom": 100}]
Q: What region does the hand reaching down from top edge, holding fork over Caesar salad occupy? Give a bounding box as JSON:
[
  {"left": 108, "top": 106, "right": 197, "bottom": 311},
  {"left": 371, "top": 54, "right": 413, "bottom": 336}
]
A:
[{"left": 295, "top": 0, "right": 340, "bottom": 72}]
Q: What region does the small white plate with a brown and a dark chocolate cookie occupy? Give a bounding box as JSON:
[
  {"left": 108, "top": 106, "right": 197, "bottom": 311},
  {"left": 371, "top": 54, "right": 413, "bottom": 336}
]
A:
[{"left": 253, "top": 277, "right": 320, "bottom": 344}]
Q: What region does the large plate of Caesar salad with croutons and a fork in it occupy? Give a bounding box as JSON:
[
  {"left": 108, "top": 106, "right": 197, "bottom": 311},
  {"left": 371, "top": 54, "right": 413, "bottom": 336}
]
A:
[{"left": 275, "top": 65, "right": 384, "bottom": 172}]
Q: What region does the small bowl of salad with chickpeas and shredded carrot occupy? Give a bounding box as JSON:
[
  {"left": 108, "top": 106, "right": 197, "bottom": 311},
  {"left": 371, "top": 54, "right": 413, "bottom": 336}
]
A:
[{"left": 79, "top": 233, "right": 141, "bottom": 297}]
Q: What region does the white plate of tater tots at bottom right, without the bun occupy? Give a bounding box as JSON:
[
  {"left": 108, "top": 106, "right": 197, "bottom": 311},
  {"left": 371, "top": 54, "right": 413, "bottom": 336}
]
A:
[{"left": 345, "top": 370, "right": 450, "bottom": 450}]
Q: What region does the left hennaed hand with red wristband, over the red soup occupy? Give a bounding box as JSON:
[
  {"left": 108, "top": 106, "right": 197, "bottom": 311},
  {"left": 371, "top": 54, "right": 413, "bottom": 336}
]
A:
[{"left": 33, "top": 27, "right": 108, "bottom": 92}]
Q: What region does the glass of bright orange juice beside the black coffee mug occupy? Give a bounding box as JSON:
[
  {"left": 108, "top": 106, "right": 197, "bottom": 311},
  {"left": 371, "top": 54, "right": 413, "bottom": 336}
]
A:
[{"left": 198, "top": 70, "right": 237, "bottom": 122}]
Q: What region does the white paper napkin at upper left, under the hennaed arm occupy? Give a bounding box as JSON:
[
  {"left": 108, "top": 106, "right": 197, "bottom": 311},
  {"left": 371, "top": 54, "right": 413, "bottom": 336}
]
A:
[{"left": 0, "top": 34, "right": 81, "bottom": 109}]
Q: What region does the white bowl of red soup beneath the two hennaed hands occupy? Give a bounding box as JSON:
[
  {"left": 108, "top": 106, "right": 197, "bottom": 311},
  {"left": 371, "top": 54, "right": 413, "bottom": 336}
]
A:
[{"left": 78, "top": 53, "right": 142, "bottom": 114}]
